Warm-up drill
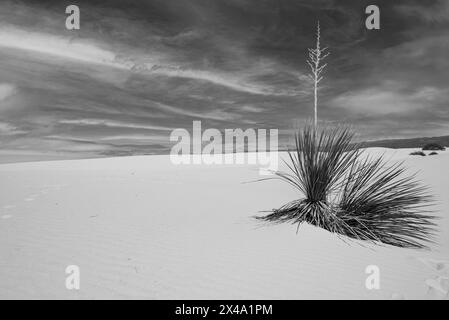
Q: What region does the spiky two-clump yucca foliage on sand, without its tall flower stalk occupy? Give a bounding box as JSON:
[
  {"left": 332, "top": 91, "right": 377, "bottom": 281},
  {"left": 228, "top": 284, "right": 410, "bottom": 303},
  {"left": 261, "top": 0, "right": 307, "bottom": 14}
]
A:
[{"left": 258, "top": 126, "right": 434, "bottom": 248}]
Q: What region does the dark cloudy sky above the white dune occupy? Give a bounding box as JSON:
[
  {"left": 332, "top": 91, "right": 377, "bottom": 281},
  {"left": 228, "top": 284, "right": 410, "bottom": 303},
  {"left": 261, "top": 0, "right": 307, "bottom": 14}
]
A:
[{"left": 0, "top": 0, "right": 449, "bottom": 162}]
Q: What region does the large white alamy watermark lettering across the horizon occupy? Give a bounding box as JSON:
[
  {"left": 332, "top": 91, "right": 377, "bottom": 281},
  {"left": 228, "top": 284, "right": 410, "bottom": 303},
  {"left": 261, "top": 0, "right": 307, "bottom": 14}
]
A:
[{"left": 170, "top": 121, "right": 279, "bottom": 175}]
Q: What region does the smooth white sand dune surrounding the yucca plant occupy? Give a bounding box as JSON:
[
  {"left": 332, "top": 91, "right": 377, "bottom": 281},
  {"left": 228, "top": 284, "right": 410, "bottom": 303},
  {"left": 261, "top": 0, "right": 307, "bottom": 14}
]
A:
[{"left": 0, "top": 148, "right": 449, "bottom": 299}]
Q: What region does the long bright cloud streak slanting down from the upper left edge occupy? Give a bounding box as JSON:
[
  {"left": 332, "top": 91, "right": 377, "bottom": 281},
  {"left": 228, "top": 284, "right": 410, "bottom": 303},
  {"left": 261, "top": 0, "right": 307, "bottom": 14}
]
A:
[{"left": 0, "top": 26, "right": 297, "bottom": 96}]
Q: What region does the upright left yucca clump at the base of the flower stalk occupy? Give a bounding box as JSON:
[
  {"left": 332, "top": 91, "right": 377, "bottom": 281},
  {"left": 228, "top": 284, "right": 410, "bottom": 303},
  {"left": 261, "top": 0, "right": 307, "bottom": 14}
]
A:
[{"left": 261, "top": 127, "right": 359, "bottom": 226}]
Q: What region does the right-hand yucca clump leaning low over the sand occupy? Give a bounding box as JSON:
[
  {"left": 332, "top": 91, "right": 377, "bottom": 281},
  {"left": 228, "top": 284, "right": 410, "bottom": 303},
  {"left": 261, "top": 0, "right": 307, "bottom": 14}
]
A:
[{"left": 338, "top": 157, "right": 434, "bottom": 248}]
